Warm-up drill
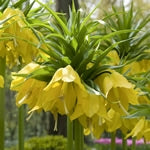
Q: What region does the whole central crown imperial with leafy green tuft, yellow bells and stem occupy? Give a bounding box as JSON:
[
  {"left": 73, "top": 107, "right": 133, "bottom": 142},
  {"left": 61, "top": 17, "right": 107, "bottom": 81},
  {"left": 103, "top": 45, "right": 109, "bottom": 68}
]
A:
[{"left": 11, "top": 0, "right": 149, "bottom": 150}]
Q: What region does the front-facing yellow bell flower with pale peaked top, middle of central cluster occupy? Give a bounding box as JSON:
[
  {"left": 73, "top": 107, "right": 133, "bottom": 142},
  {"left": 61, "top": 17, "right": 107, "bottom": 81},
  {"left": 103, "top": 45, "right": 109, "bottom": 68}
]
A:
[{"left": 30, "top": 65, "right": 84, "bottom": 114}]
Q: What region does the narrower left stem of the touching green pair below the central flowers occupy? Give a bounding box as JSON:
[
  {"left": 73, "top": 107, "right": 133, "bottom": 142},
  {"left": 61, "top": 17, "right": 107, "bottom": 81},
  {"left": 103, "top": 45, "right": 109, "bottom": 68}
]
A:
[{"left": 67, "top": 117, "right": 73, "bottom": 150}]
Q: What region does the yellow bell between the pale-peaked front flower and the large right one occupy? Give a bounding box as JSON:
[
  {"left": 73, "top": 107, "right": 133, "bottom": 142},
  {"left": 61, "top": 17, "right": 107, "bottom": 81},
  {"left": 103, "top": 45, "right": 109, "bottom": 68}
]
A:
[{"left": 71, "top": 88, "right": 106, "bottom": 120}]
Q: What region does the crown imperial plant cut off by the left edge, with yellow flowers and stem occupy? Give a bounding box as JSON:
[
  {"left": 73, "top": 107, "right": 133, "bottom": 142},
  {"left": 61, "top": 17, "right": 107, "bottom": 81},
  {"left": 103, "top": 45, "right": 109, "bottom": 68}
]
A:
[{"left": 0, "top": 0, "right": 38, "bottom": 150}]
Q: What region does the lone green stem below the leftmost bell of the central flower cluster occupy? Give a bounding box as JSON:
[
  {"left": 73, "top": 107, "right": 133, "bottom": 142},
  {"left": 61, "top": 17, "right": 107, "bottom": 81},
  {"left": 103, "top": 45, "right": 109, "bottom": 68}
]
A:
[{"left": 18, "top": 106, "right": 24, "bottom": 150}]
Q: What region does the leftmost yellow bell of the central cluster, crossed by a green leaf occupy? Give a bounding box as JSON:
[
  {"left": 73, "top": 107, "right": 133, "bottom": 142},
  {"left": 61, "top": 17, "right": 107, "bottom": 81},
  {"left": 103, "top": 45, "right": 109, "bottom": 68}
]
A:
[{"left": 11, "top": 63, "right": 47, "bottom": 109}]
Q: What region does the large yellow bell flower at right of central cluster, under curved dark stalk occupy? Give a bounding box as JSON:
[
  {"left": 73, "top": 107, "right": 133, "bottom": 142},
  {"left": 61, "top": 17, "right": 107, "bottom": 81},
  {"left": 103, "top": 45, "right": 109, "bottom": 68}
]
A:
[{"left": 95, "top": 70, "right": 138, "bottom": 114}]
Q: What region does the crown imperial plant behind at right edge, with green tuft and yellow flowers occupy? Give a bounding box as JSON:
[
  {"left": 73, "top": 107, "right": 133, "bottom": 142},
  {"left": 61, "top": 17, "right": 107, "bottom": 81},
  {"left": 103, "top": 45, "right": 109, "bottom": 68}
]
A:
[{"left": 98, "top": 3, "right": 150, "bottom": 149}]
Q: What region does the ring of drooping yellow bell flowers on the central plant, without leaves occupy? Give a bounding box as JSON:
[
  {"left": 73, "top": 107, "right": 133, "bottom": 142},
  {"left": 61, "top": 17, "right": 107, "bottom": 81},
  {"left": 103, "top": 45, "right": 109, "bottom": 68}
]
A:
[{"left": 11, "top": 63, "right": 138, "bottom": 137}]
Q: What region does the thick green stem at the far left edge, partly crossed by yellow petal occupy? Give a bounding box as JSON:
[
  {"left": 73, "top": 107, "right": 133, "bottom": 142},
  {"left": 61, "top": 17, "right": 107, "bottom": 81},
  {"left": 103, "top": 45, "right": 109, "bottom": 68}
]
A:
[{"left": 0, "top": 57, "right": 6, "bottom": 150}]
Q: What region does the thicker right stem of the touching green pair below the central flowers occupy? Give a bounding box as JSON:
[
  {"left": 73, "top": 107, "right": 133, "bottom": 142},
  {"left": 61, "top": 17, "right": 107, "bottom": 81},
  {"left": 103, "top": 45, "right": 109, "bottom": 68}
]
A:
[{"left": 74, "top": 120, "right": 84, "bottom": 150}]
